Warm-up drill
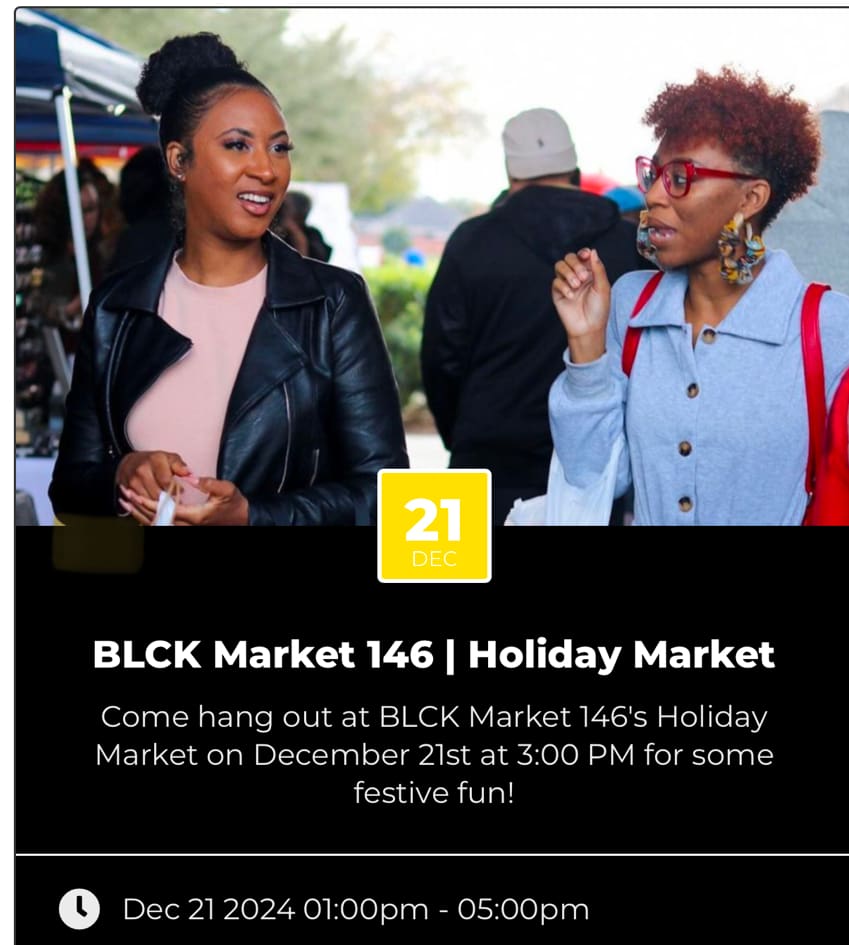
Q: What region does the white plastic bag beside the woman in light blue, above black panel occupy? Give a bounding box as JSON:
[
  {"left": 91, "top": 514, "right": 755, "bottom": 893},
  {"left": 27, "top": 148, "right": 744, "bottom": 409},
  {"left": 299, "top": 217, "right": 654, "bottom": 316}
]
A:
[{"left": 504, "top": 434, "right": 625, "bottom": 525}]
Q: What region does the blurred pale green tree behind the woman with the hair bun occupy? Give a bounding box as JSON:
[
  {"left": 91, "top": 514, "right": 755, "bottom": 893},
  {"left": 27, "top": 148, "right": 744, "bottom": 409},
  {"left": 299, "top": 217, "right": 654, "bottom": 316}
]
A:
[{"left": 53, "top": 7, "right": 481, "bottom": 213}]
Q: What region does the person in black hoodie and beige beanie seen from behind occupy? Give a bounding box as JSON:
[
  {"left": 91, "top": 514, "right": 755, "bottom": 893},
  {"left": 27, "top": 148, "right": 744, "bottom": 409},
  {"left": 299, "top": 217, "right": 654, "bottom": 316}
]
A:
[{"left": 421, "top": 108, "right": 647, "bottom": 525}]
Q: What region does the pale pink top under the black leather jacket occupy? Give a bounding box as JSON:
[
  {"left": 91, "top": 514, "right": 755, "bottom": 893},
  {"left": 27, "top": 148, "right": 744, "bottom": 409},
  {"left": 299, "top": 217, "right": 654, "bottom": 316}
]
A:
[{"left": 127, "top": 261, "right": 268, "bottom": 477}]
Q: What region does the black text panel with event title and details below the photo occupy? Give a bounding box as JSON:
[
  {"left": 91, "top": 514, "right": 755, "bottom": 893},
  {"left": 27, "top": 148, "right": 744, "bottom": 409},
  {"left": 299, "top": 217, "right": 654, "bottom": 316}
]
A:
[{"left": 16, "top": 529, "right": 847, "bottom": 942}]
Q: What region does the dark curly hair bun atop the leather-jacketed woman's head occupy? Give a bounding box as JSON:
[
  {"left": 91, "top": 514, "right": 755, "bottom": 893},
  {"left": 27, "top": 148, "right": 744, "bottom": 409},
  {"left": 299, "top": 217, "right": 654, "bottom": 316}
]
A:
[{"left": 136, "top": 33, "right": 244, "bottom": 115}]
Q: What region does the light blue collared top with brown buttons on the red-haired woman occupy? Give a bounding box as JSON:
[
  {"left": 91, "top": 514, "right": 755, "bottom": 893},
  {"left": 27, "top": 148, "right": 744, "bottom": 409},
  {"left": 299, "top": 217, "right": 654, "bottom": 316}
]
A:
[{"left": 549, "top": 251, "right": 849, "bottom": 525}]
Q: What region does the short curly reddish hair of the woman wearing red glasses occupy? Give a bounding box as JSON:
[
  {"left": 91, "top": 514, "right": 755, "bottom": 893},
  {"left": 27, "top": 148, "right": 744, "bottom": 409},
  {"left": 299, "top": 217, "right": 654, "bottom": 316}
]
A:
[{"left": 643, "top": 66, "right": 821, "bottom": 229}]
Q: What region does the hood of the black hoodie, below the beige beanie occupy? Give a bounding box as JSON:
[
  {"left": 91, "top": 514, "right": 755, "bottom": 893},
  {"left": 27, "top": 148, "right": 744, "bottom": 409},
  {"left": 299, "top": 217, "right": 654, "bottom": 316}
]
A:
[{"left": 492, "top": 184, "right": 620, "bottom": 266}]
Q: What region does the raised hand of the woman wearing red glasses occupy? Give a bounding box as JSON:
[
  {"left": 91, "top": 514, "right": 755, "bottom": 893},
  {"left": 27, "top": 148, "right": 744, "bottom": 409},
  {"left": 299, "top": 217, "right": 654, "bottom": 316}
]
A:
[{"left": 551, "top": 249, "right": 610, "bottom": 364}]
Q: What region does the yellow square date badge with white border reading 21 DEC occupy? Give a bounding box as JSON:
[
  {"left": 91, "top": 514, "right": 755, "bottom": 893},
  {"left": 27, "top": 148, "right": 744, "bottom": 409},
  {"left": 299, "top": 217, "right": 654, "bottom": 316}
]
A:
[{"left": 377, "top": 469, "right": 492, "bottom": 584}]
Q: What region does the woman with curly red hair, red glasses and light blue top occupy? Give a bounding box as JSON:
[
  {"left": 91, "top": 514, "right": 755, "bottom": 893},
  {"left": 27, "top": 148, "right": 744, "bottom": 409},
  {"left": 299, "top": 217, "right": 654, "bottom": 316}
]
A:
[{"left": 549, "top": 68, "right": 849, "bottom": 525}]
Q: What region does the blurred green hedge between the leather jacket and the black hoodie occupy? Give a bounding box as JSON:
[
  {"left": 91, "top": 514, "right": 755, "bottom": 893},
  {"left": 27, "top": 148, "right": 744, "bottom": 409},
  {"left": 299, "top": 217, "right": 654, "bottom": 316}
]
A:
[{"left": 363, "top": 259, "right": 436, "bottom": 404}]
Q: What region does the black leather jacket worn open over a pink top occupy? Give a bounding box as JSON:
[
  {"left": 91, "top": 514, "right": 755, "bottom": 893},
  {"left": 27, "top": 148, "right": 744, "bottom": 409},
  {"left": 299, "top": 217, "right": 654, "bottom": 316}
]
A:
[{"left": 50, "top": 234, "right": 409, "bottom": 525}]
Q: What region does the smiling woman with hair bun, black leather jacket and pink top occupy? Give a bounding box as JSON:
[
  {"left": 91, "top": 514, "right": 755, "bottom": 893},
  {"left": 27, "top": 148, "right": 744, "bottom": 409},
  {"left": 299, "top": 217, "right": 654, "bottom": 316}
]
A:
[{"left": 50, "top": 33, "right": 408, "bottom": 525}]
